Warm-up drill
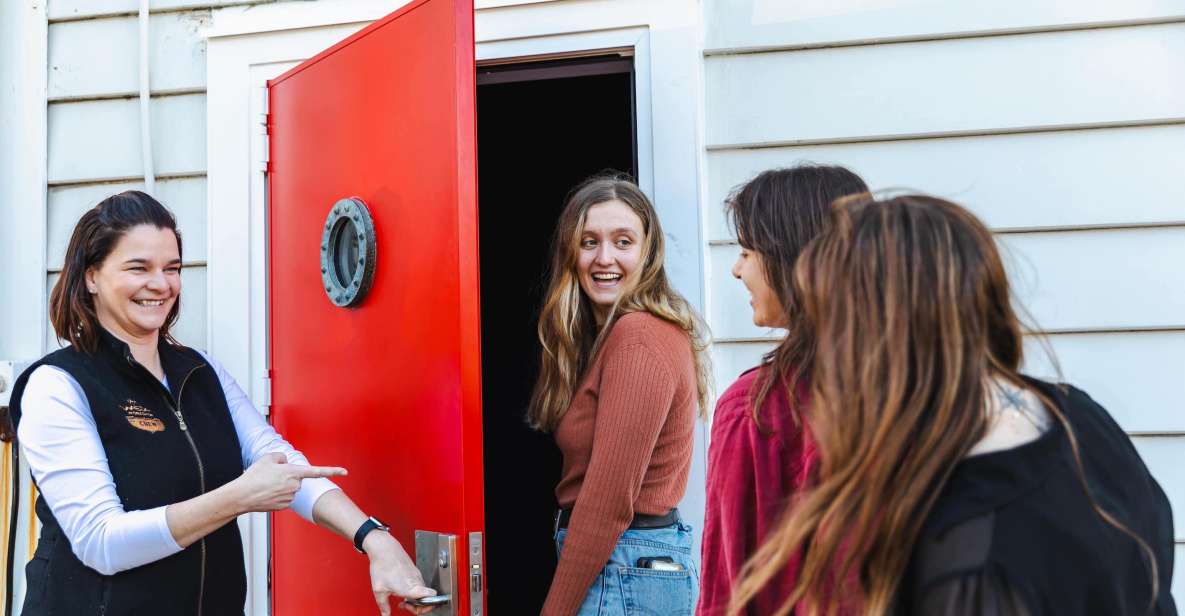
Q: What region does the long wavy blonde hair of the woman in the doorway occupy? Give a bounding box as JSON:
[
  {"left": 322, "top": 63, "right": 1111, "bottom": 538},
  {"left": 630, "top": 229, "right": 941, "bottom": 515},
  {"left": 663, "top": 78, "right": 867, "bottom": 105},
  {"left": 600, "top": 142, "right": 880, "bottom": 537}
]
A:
[{"left": 527, "top": 174, "right": 709, "bottom": 431}]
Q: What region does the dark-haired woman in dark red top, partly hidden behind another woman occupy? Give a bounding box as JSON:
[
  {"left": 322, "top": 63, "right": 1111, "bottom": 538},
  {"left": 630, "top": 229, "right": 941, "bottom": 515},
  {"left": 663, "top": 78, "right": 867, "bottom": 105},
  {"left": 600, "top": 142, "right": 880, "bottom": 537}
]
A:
[{"left": 697, "top": 165, "right": 869, "bottom": 616}]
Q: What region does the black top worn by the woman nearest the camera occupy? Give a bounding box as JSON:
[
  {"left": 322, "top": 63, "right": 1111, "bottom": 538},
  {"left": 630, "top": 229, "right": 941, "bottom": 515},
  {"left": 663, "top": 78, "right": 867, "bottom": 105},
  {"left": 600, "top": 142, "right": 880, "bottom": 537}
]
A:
[{"left": 895, "top": 379, "right": 1177, "bottom": 616}]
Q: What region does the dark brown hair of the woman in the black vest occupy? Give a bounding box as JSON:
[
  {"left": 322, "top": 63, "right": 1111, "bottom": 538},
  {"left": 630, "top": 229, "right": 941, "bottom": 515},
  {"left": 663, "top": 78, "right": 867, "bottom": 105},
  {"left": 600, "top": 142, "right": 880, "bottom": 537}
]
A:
[{"left": 50, "top": 191, "right": 181, "bottom": 353}]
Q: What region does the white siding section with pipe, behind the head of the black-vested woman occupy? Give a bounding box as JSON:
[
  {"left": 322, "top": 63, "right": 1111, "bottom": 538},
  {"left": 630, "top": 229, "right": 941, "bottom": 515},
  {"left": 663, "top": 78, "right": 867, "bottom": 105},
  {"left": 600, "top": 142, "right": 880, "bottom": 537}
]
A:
[{"left": 45, "top": 5, "right": 215, "bottom": 364}]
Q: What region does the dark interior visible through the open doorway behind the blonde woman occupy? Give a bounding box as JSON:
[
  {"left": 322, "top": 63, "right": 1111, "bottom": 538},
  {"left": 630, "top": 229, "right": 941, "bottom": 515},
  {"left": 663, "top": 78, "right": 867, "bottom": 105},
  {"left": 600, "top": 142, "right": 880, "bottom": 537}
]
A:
[{"left": 478, "top": 56, "right": 638, "bottom": 616}]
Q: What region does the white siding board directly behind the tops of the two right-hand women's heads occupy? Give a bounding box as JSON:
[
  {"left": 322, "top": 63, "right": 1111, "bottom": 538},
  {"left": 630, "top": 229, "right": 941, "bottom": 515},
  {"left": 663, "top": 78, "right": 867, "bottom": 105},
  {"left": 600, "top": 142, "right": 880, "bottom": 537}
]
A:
[{"left": 707, "top": 124, "right": 1185, "bottom": 238}]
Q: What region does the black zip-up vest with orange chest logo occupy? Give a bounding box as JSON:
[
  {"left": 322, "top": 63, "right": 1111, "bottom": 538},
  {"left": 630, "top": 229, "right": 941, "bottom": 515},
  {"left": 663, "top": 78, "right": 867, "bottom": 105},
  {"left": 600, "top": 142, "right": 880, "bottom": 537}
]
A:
[{"left": 11, "top": 329, "right": 246, "bottom": 616}]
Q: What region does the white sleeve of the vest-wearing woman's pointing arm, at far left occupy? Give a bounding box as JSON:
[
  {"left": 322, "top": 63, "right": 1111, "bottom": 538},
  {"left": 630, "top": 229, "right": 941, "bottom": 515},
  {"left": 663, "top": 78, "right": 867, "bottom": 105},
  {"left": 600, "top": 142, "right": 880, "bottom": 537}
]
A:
[{"left": 17, "top": 366, "right": 181, "bottom": 576}]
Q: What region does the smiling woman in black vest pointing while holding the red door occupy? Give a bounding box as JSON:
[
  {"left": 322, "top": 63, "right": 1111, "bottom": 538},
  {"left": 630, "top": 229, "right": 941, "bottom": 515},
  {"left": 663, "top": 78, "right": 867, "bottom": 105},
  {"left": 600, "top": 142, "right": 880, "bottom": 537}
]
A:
[{"left": 11, "top": 191, "right": 435, "bottom": 616}]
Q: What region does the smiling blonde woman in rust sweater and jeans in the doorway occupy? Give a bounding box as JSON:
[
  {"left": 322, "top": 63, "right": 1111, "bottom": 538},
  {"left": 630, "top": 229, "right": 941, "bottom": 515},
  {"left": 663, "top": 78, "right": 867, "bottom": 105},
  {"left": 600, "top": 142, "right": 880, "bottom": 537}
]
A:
[{"left": 529, "top": 175, "right": 707, "bottom": 616}]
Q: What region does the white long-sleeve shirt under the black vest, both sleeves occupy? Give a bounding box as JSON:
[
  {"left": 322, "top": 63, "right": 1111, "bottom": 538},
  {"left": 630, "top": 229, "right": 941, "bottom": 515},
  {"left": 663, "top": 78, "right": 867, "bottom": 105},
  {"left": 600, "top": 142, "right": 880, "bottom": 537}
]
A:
[{"left": 17, "top": 353, "right": 338, "bottom": 576}]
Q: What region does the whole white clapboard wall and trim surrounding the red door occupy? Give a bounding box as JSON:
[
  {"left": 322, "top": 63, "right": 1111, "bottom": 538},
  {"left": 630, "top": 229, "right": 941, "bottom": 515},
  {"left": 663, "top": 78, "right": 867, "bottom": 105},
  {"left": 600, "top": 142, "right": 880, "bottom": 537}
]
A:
[{"left": 9, "top": 0, "right": 1185, "bottom": 614}]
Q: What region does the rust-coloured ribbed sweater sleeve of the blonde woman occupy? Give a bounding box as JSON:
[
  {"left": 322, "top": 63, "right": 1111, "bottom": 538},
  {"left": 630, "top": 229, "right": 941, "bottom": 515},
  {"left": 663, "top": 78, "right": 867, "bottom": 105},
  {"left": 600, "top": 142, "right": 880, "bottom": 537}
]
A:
[{"left": 543, "top": 344, "right": 677, "bottom": 616}]
